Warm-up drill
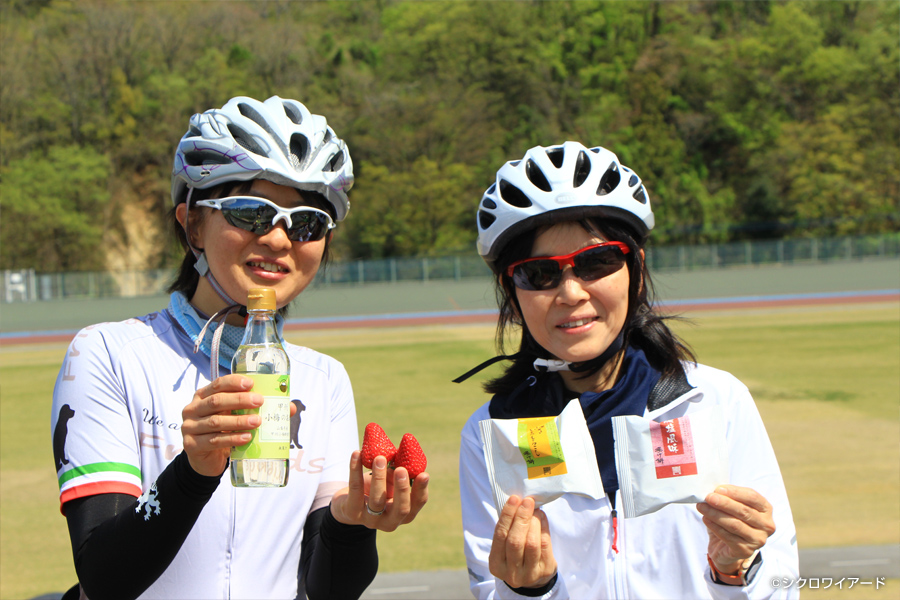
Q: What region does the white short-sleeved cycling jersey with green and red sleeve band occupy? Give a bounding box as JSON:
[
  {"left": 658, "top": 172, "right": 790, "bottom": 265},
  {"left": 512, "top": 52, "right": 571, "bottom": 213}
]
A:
[{"left": 51, "top": 311, "right": 359, "bottom": 600}]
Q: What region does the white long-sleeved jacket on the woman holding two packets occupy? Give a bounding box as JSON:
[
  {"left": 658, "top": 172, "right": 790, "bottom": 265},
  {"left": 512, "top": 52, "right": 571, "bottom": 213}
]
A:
[{"left": 459, "top": 365, "right": 798, "bottom": 600}]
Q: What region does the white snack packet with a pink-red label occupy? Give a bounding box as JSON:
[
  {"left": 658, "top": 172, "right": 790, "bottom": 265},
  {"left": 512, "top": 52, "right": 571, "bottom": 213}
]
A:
[{"left": 612, "top": 406, "right": 728, "bottom": 519}]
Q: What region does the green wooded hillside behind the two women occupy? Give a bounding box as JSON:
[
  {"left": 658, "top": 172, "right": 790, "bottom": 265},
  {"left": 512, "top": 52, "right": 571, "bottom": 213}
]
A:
[{"left": 0, "top": 0, "right": 900, "bottom": 272}]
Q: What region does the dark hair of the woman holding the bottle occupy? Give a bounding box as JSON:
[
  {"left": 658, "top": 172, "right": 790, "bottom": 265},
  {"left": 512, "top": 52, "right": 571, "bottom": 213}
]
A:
[{"left": 166, "top": 180, "right": 336, "bottom": 315}]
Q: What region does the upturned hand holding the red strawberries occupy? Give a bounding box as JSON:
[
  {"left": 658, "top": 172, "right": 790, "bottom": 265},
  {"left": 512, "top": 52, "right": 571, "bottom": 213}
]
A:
[{"left": 331, "top": 450, "right": 429, "bottom": 531}]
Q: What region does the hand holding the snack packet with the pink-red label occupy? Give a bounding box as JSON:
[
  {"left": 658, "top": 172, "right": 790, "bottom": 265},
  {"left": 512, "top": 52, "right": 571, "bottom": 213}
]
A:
[{"left": 697, "top": 485, "right": 775, "bottom": 574}]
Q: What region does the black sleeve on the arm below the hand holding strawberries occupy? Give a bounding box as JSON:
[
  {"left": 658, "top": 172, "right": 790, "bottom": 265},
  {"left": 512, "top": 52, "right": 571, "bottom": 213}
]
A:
[{"left": 297, "top": 507, "right": 378, "bottom": 600}]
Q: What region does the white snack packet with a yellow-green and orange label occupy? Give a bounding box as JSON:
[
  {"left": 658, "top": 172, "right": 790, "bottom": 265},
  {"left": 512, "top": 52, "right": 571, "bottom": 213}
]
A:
[{"left": 479, "top": 400, "right": 603, "bottom": 512}]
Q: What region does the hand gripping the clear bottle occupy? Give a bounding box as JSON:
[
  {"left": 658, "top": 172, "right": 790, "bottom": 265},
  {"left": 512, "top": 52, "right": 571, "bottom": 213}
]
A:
[{"left": 181, "top": 374, "right": 297, "bottom": 477}]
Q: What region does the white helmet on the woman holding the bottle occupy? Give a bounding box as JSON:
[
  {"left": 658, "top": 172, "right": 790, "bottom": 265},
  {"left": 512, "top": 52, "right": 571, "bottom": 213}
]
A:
[{"left": 172, "top": 96, "right": 353, "bottom": 221}]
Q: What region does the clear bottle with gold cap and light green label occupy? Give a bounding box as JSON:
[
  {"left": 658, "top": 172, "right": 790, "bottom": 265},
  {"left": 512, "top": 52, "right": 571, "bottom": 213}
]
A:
[{"left": 231, "top": 288, "right": 291, "bottom": 487}]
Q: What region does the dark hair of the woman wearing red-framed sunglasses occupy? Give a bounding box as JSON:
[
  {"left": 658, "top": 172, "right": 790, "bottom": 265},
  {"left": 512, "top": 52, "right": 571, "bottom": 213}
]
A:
[{"left": 484, "top": 218, "right": 696, "bottom": 394}]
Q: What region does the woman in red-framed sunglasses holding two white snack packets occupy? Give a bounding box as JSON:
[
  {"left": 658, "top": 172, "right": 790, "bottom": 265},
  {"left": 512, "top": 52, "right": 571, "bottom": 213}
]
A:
[{"left": 460, "top": 142, "right": 798, "bottom": 599}]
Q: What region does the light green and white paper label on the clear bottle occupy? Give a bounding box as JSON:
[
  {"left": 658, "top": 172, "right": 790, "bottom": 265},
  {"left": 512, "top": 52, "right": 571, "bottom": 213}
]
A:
[{"left": 231, "top": 373, "right": 291, "bottom": 460}]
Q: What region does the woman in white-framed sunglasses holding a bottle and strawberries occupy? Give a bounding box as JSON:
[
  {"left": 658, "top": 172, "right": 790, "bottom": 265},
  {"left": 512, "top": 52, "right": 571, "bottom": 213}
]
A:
[{"left": 52, "top": 97, "right": 428, "bottom": 600}]
